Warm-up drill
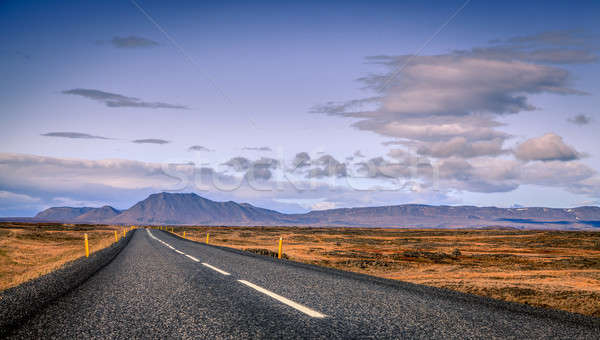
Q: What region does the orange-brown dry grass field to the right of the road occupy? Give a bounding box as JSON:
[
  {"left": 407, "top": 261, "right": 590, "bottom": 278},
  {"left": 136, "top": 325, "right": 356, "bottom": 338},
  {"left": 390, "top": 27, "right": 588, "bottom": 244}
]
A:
[{"left": 175, "top": 227, "right": 600, "bottom": 317}]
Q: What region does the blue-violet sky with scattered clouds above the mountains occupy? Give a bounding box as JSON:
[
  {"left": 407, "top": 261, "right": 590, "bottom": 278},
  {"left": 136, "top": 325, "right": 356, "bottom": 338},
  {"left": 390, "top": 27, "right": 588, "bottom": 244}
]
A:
[{"left": 0, "top": 0, "right": 600, "bottom": 216}]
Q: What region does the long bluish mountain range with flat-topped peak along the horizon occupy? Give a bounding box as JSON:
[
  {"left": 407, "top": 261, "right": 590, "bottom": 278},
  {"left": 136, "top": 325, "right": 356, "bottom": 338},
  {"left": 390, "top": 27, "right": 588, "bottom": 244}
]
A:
[{"left": 34, "top": 192, "right": 600, "bottom": 229}]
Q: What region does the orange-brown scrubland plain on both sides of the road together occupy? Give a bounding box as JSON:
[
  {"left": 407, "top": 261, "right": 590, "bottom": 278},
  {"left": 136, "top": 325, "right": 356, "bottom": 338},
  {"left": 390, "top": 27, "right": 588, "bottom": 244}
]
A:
[{"left": 0, "top": 223, "right": 600, "bottom": 317}]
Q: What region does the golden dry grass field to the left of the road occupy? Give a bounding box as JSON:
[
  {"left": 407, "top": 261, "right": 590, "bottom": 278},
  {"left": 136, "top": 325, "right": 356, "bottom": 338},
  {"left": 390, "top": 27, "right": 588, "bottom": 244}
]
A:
[{"left": 0, "top": 223, "right": 121, "bottom": 290}]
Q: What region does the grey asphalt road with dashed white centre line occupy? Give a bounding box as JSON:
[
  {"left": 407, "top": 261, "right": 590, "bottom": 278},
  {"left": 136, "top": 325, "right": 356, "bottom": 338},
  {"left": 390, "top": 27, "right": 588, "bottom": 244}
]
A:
[{"left": 5, "top": 229, "right": 600, "bottom": 339}]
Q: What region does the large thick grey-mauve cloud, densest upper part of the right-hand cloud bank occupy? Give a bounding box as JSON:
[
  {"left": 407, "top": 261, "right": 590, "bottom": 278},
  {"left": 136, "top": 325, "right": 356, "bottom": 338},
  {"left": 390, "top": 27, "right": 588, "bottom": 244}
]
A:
[{"left": 363, "top": 54, "right": 583, "bottom": 116}]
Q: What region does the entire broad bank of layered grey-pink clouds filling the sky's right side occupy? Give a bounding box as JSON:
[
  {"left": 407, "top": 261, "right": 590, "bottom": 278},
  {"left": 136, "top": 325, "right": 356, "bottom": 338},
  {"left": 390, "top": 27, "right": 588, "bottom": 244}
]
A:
[{"left": 313, "top": 32, "right": 598, "bottom": 196}]
